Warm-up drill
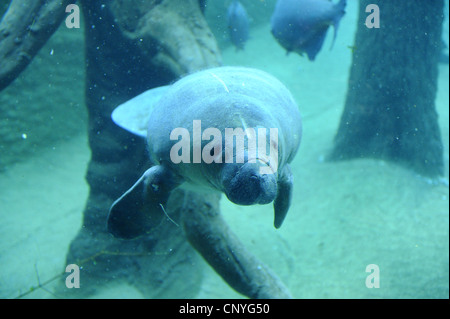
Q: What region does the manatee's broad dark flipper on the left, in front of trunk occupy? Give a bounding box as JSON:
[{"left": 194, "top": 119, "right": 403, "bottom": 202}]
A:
[{"left": 107, "top": 165, "right": 180, "bottom": 239}]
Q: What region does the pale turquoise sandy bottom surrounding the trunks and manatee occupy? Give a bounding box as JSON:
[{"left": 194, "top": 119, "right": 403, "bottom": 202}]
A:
[{"left": 0, "top": 4, "right": 449, "bottom": 298}]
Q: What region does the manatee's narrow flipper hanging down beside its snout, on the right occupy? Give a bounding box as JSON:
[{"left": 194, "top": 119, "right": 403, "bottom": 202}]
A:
[{"left": 273, "top": 164, "right": 294, "bottom": 228}]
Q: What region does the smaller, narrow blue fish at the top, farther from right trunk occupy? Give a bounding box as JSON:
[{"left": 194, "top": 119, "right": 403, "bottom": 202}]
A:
[{"left": 227, "top": 0, "right": 249, "bottom": 49}]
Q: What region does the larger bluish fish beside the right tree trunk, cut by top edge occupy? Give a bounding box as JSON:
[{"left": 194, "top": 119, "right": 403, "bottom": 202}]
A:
[{"left": 271, "top": 0, "right": 347, "bottom": 61}]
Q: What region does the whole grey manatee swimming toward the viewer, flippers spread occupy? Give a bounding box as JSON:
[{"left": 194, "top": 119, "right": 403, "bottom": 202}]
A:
[{"left": 107, "top": 67, "right": 302, "bottom": 238}]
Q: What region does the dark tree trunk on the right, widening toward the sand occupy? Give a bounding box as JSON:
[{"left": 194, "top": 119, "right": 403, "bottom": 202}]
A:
[{"left": 330, "top": 0, "right": 444, "bottom": 177}]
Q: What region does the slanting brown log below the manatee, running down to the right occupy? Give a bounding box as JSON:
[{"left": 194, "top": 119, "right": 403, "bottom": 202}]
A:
[{"left": 177, "top": 192, "right": 292, "bottom": 299}]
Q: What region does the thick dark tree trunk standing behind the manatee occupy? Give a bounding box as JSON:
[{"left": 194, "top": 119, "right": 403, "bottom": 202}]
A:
[{"left": 62, "top": 0, "right": 220, "bottom": 298}]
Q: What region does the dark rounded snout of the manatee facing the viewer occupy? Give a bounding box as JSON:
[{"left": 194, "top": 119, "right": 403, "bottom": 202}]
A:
[{"left": 222, "top": 163, "right": 277, "bottom": 205}]
